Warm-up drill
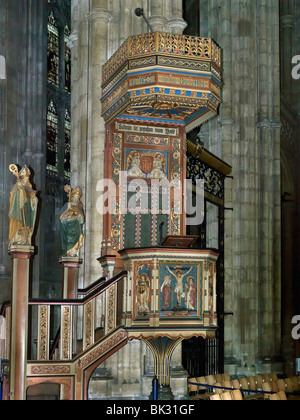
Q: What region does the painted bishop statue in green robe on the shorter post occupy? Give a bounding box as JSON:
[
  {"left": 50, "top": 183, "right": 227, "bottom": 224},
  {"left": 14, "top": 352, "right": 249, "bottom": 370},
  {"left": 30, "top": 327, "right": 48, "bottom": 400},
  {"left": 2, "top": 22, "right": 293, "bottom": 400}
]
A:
[{"left": 60, "top": 185, "right": 84, "bottom": 257}]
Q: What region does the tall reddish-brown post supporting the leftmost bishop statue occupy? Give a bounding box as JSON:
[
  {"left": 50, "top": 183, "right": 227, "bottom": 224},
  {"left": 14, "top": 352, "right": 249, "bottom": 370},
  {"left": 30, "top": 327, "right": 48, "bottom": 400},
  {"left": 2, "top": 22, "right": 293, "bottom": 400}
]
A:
[{"left": 8, "top": 245, "right": 34, "bottom": 401}]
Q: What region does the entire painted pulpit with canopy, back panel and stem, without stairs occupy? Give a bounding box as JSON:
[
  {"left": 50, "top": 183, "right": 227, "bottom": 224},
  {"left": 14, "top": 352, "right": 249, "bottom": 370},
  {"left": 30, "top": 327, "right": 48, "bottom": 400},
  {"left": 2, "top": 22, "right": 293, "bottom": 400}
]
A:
[{"left": 98, "top": 32, "right": 226, "bottom": 398}]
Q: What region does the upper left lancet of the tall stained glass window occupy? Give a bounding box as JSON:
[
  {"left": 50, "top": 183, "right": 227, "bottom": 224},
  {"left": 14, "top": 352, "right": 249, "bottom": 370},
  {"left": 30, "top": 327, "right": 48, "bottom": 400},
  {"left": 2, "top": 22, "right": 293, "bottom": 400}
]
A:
[{"left": 47, "top": 12, "right": 59, "bottom": 86}]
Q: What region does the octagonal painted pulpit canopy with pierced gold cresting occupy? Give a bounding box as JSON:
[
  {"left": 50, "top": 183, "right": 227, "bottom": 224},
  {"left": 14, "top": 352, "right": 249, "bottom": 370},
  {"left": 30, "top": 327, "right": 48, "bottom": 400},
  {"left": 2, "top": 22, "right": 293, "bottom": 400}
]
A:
[{"left": 101, "top": 32, "right": 221, "bottom": 131}]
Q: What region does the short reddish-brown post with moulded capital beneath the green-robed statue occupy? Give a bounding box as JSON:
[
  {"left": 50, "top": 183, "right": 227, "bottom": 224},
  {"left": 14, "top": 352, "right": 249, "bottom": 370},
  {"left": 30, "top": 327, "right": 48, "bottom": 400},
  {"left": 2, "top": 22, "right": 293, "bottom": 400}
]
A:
[{"left": 59, "top": 257, "right": 82, "bottom": 299}]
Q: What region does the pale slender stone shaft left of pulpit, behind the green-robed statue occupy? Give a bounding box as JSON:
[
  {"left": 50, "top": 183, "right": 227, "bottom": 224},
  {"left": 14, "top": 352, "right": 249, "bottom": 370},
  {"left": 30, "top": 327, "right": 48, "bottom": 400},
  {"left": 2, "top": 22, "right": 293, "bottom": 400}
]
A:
[{"left": 82, "top": 0, "right": 112, "bottom": 282}]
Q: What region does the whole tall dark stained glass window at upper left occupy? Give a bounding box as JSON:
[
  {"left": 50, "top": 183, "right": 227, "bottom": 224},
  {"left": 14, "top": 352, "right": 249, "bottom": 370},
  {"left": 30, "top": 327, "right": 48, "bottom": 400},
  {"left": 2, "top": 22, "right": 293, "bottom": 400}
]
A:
[{"left": 47, "top": 1, "right": 71, "bottom": 179}]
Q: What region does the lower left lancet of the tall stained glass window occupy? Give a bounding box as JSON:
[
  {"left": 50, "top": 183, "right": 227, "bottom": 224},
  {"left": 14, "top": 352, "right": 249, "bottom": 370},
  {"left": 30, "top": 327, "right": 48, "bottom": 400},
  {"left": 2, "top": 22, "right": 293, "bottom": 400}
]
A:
[{"left": 47, "top": 100, "right": 58, "bottom": 173}]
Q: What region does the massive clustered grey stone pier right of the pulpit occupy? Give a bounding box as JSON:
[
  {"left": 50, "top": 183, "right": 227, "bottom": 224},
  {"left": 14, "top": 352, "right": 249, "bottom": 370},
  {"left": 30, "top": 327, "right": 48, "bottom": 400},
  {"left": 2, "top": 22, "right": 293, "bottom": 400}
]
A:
[{"left": 200, "top": 0, "right": 280, "bottom": 374}]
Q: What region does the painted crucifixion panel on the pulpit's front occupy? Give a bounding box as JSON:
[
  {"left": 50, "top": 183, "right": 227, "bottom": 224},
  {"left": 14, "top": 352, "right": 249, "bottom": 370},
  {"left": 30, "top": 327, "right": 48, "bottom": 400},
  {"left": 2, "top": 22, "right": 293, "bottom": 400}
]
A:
[{"left": 160, "top": 263, "right": 202, "bottom": 319}]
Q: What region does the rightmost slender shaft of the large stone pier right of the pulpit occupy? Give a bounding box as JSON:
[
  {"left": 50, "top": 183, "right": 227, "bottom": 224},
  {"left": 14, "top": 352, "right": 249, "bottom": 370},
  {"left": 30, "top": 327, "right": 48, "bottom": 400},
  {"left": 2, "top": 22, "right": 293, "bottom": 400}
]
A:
[{"left": 257, "top": 0, "right": 282, "bottom": 363}]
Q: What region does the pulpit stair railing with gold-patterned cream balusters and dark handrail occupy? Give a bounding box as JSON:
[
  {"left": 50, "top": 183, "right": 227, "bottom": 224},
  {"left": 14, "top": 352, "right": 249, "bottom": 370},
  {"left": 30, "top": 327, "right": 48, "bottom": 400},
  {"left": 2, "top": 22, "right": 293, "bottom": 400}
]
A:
[{"left": 0, "top": 271, "right": 127, "bottom": 361}]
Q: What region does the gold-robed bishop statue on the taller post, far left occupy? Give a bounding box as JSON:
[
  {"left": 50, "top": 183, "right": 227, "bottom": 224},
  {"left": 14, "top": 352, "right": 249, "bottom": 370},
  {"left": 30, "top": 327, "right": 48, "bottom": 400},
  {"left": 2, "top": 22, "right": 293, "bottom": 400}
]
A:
[{"left": 8, "top": 165, "right": 38, "bottom": 246}]
